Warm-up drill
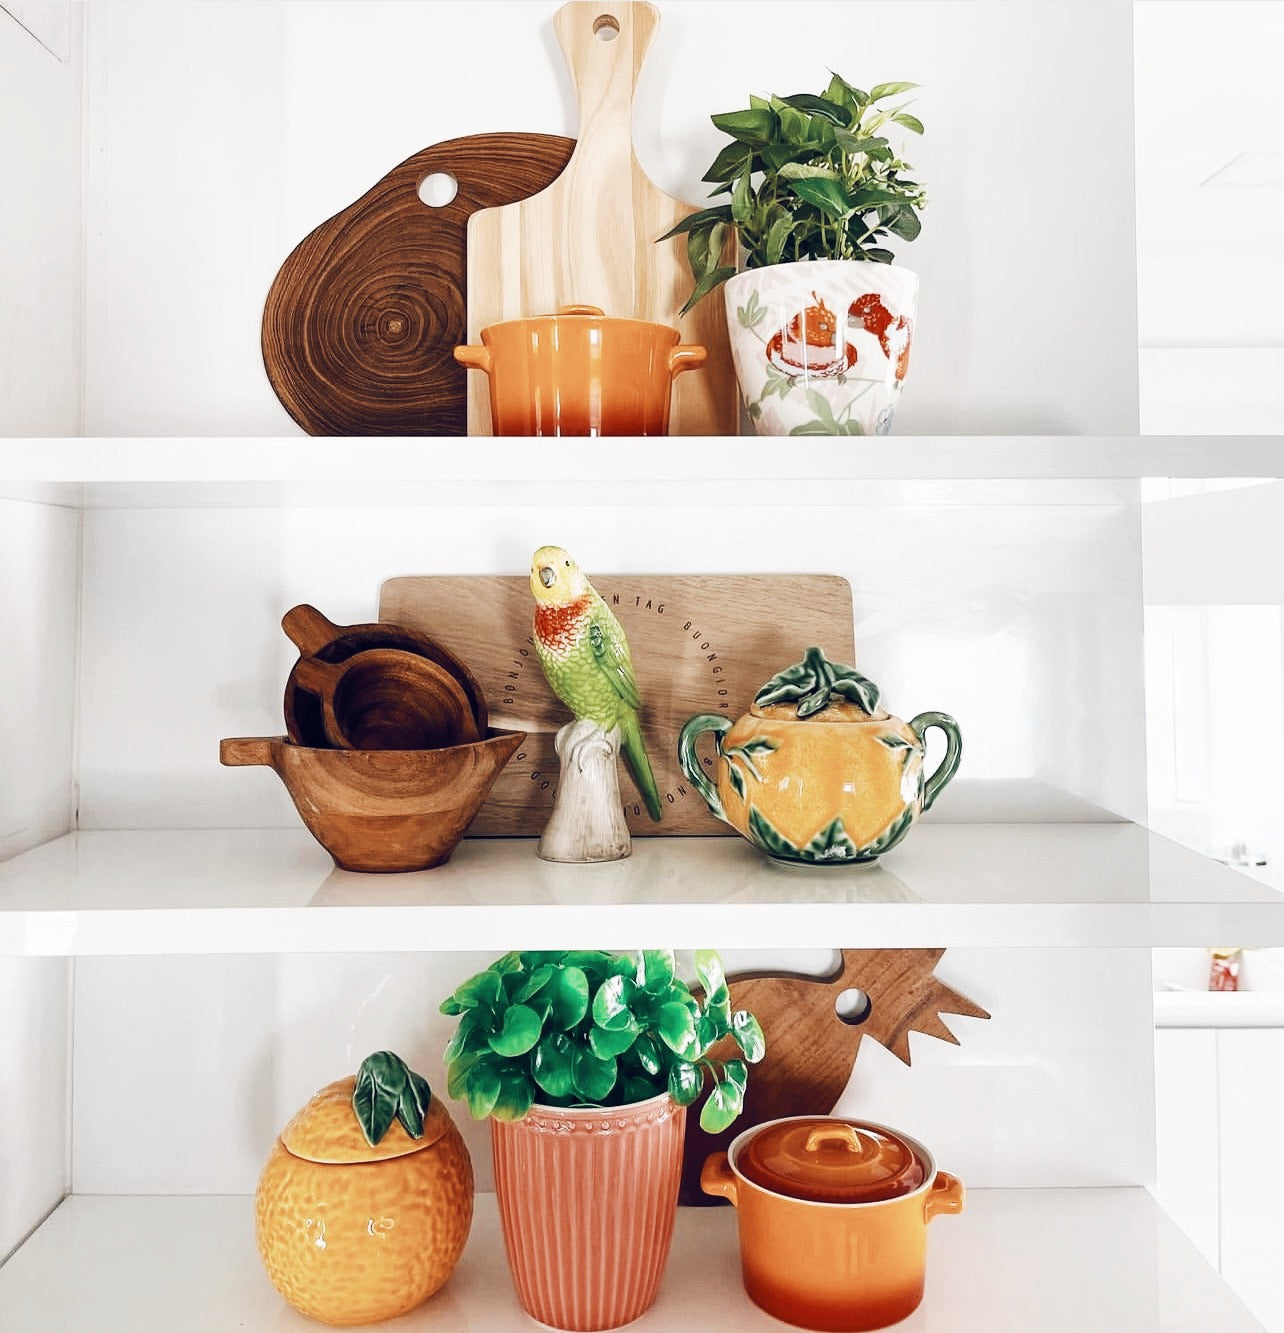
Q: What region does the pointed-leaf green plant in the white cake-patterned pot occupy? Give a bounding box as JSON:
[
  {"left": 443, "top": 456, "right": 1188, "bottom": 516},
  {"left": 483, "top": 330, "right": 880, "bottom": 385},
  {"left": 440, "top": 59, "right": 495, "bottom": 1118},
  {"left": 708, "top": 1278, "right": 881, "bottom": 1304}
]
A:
[{"left": 660, "top": 75, "right": 927, "bottom": 313}]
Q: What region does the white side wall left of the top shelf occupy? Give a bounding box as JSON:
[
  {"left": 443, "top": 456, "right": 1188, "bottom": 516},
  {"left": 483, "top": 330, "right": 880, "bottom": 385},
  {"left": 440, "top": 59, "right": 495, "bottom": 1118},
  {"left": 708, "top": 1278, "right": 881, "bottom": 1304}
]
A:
[{"left": 0, "top": 4, "right": 83, "bottom": 436}]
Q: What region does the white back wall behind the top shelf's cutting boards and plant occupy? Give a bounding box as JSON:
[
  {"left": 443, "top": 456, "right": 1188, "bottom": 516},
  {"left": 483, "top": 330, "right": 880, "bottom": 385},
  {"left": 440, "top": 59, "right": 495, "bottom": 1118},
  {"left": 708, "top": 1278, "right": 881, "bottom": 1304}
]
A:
[{"left": 87, "top": 0, "right": 1137, "bottom": 435}]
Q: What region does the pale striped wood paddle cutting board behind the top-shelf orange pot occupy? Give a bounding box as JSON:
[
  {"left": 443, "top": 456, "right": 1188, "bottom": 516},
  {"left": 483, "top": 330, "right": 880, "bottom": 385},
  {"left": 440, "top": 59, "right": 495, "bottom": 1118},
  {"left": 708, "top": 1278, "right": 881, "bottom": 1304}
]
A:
[{"left": 468, "top": 0, "right": 739, "bottom": 435}]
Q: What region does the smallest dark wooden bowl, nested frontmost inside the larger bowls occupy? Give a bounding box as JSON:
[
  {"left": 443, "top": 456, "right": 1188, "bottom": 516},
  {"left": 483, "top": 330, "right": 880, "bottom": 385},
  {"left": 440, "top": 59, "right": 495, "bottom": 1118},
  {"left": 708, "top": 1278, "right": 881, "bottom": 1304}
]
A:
[{"left": 296, "top": 648, "right": 481, "bottom": 750}]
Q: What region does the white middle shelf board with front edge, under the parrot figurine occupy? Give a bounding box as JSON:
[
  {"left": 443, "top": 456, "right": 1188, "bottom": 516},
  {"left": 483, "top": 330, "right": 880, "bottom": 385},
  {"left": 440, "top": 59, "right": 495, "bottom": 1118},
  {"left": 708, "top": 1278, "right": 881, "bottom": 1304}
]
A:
[{"left": 0, "top": 822, "right": 1284, "bottom": 956}]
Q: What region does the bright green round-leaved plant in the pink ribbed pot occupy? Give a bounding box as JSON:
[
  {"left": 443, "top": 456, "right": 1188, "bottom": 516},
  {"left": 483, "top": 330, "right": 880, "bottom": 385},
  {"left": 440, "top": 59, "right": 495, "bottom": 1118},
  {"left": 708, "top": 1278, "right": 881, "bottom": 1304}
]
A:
[{"left": 441, "top": 949, "right": 765, "bottom": 1133}]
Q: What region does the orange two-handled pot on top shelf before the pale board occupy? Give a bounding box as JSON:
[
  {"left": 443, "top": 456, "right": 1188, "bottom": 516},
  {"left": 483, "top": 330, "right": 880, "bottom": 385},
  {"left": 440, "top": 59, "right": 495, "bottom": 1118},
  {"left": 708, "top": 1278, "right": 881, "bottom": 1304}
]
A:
[{"left": 455, "top": 305, "right": 705, "bottom": 435}]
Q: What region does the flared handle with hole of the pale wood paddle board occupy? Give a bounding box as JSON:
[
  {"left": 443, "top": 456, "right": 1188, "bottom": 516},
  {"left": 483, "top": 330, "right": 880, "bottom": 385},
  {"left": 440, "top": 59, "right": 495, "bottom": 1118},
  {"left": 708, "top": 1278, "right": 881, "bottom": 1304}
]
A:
[{"left": 553, "top": 0, "right": 660, "bottom": 167}]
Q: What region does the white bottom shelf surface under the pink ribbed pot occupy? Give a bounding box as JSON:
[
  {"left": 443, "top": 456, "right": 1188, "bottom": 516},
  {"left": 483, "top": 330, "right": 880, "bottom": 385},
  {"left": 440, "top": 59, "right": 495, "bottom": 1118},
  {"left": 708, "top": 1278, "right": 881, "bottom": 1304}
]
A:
[{"left": 0, "top": 1188, "right": 1261, "bottom": 1333}]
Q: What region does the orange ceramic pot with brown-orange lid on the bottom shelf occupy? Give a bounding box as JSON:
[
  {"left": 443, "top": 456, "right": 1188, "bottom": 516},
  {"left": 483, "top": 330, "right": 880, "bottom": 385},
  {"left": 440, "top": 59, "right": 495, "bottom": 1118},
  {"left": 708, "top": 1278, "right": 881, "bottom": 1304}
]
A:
[{"left": 700, "top": 1116, "right": 963, "bottom": 1333}]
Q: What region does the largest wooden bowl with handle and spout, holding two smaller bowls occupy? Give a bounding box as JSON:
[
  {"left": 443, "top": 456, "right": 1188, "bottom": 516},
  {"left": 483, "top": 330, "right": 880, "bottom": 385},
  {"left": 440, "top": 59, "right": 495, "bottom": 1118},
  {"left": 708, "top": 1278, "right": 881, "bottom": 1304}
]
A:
[{"left": 219, "top": 728, "right": 525, "bottom": 874}]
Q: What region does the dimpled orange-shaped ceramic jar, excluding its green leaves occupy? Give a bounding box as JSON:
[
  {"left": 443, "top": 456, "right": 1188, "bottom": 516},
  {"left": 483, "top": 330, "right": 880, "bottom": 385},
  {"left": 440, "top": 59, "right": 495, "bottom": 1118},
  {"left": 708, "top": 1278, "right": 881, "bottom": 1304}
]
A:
[{"left": 255, "top": 1061, "right": 473, "bottom": 1325}]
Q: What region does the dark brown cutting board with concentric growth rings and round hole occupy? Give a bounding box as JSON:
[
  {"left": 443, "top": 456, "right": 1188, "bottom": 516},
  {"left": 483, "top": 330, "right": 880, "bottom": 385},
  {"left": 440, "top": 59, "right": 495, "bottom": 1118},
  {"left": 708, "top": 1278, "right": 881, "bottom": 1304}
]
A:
[{"left": 263, "top": 133, "right": 575, "bottom": 435}]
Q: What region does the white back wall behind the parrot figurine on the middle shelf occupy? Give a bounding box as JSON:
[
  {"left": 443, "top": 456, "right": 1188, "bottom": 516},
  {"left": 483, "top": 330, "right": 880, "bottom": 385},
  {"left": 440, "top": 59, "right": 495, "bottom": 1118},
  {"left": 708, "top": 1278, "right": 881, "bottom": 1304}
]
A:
[{"left": 80, "top": 483, "right": 1145, "bottom": 828}]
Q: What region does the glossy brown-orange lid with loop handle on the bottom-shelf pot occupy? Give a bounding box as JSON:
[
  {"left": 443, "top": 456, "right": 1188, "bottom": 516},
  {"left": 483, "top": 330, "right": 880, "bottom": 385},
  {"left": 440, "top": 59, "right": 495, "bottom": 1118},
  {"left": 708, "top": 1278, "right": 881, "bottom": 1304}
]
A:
[{"left": 736, "top": 1116, "right": 927, "bottom": 1204}]
